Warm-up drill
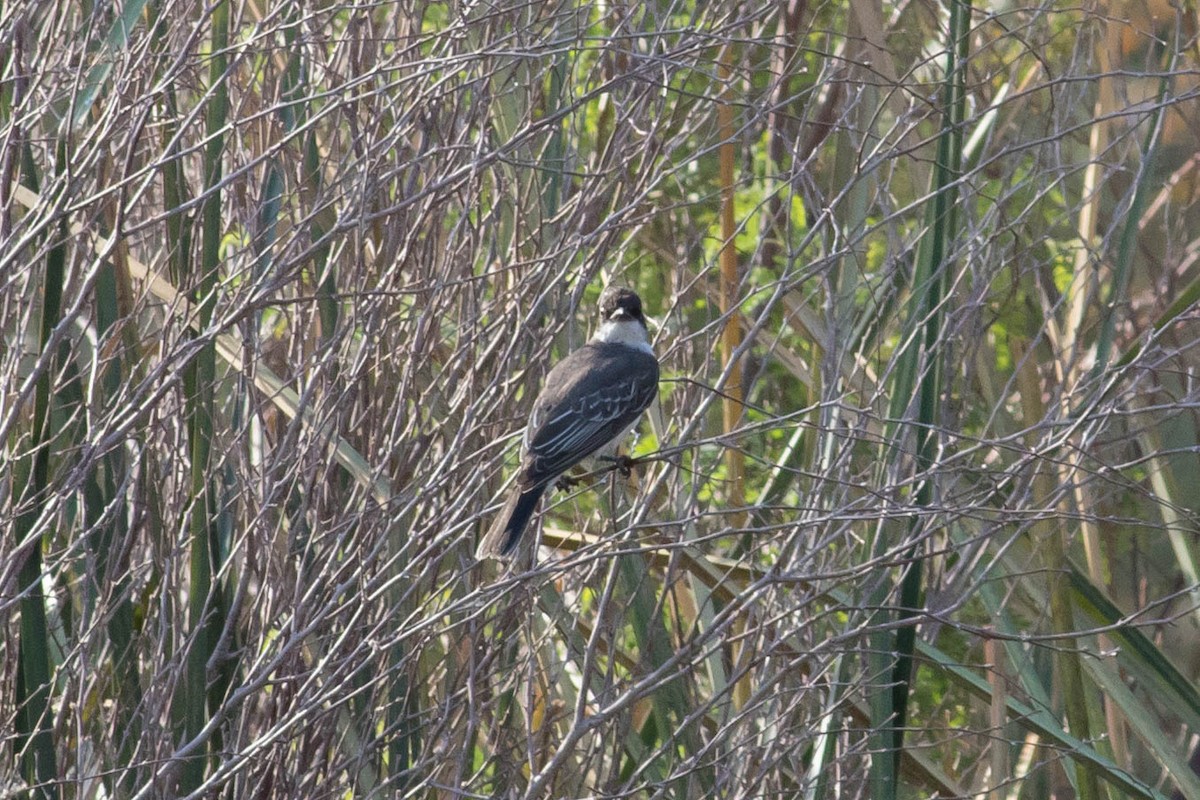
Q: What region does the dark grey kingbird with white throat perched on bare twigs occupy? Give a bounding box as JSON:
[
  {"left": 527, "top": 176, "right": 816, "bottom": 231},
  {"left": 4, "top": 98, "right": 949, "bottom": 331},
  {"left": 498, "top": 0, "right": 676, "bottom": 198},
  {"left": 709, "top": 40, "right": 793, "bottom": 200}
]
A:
[{"left": 476, "top": 287, "right": 659, "bottom": 558}]
